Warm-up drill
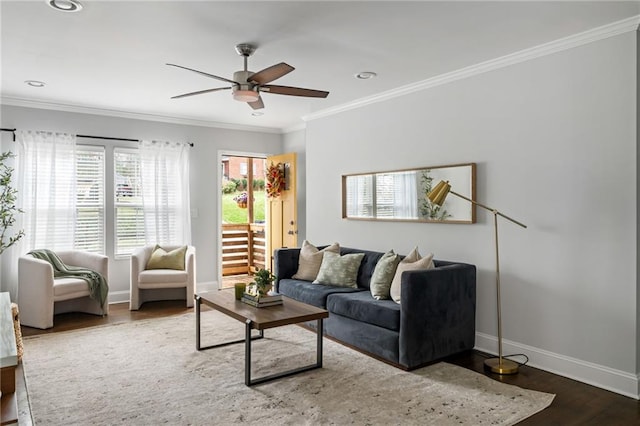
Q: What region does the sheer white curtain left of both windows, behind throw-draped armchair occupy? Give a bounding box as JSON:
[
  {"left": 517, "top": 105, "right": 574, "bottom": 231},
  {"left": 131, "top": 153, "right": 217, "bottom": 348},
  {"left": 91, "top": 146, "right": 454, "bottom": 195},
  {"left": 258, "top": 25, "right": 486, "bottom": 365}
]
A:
[{"left": 2, "top": 130, "right": 76, "bottom": 300}]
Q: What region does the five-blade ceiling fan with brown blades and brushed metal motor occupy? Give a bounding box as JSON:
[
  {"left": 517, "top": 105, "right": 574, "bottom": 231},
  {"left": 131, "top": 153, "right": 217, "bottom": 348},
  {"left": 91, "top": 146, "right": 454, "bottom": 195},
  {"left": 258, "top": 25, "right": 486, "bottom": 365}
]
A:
[{"left": 167, "top": 43, "right": 329, "bottom": 109}]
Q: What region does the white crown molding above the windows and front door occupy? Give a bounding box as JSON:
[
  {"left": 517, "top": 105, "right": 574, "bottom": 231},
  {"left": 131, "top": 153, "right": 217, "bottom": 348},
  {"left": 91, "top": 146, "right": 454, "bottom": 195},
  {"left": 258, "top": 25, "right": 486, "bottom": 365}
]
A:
[{"left": 0, "top": 96, "right": 282, "bottom": 134}]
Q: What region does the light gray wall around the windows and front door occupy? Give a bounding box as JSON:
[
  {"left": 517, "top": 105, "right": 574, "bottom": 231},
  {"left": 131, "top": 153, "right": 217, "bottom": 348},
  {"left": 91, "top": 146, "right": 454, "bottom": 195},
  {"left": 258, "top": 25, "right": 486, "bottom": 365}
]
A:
[{"left": 0, "top": 105, "right": 282, "bottom": 302}]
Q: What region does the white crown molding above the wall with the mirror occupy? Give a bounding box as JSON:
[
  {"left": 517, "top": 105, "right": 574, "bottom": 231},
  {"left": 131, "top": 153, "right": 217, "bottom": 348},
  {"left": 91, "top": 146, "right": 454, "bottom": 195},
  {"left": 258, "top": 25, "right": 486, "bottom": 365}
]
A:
[{"left": 302, "top": 15, "right": 640, "bottom": 121}]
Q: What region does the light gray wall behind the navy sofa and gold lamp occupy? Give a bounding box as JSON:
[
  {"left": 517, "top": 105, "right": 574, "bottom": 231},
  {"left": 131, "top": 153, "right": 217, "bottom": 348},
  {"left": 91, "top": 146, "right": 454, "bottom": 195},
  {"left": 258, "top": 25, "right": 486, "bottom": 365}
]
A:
[{"left": 306, "top": 32, "right": 640, "bottom": 397}]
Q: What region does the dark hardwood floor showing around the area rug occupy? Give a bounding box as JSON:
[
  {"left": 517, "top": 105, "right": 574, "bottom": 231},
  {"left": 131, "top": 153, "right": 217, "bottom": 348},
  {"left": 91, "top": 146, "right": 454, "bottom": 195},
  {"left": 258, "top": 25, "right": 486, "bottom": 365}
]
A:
[{"left": 17, "top": 301, "right": 640, "bottom": 426}]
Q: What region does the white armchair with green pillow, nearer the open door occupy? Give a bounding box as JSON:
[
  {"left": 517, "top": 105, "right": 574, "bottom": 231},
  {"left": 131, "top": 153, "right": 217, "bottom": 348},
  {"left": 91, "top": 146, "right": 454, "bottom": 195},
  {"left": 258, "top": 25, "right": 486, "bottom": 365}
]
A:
[{"left": 129, "top": 245, "right": 196, "bottom": 311}]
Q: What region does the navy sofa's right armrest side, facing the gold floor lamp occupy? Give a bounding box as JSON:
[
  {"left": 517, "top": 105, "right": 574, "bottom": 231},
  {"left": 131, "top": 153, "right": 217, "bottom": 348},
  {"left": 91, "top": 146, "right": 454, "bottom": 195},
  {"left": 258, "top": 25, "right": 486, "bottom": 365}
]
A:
[{"left": 399, "top": 263, "right": 476, "bottom": 368}]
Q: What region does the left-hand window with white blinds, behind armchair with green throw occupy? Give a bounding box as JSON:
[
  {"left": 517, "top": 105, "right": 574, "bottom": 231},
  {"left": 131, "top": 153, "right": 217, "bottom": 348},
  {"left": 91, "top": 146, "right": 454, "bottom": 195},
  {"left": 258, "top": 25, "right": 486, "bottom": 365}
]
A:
[{"left": 74, "top": 145, "right": 105, "bottom": 253}]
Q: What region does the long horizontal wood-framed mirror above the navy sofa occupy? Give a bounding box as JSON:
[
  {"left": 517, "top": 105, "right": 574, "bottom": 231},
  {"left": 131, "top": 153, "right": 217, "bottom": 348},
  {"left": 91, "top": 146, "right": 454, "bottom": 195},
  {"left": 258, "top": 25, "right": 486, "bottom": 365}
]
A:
[{"left": 342, "top": 163, "right": 476, "bottom": 223}]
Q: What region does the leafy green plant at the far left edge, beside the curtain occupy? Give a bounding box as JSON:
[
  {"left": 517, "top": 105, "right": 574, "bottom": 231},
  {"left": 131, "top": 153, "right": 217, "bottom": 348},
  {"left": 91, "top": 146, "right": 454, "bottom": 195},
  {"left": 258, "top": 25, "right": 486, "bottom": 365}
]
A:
[{"left": 0, "top": 151, "right": 24, "bottom": 254}]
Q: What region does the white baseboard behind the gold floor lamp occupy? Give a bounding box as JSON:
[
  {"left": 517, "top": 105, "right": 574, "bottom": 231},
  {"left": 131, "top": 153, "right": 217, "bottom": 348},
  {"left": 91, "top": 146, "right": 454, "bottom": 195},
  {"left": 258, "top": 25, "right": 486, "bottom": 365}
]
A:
[{"left": 475, "top": 332, "right": 640, "bottom": 400}]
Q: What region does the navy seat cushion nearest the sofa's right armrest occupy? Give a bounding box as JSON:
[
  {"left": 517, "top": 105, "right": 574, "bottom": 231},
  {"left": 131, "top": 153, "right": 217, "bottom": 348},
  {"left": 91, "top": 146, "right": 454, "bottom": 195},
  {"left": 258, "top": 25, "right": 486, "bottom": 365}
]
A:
[{"left": 327, "top": 291, "right": 400, "bottom": 331}]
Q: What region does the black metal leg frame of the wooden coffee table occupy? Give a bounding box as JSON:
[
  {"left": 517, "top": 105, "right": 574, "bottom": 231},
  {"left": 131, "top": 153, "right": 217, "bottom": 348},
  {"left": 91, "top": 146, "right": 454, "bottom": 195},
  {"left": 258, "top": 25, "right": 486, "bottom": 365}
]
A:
[{"left": 195, "top": 295, "right": 324, "bottom": 386}]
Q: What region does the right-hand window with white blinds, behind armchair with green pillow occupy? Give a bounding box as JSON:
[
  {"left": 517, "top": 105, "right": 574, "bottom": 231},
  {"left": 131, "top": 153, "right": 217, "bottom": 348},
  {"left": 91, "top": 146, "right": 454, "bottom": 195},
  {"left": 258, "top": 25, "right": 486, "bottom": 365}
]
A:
[{"left": 113, "top": 148, "right": 145, "bottom": 257}]
